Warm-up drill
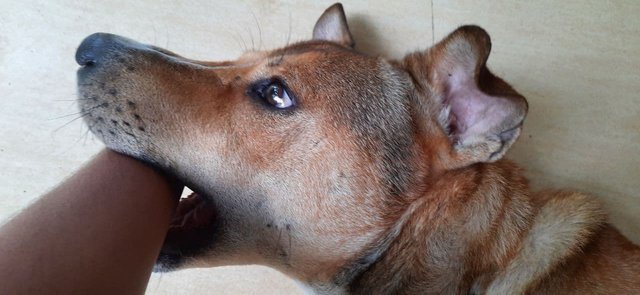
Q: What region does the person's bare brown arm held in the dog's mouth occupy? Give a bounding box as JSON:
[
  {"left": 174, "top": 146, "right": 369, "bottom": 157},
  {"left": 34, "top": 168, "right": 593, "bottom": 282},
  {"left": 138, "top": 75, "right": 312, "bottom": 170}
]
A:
[{"left": 0, "top": 150, "right": 182, "bottom": 294}]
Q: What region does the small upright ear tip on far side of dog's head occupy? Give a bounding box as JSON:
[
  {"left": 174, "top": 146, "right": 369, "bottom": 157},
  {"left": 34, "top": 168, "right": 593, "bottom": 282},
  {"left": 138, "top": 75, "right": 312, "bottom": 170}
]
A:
[{"left": 313, "top": 3, "right": 355, "bottom": 48}]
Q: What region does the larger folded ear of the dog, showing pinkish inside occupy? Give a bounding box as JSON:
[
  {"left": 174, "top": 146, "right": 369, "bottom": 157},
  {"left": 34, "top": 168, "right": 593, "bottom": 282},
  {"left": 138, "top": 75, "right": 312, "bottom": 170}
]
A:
[{"left": 404, "top": 26, "right": 528, "bottom": 168}]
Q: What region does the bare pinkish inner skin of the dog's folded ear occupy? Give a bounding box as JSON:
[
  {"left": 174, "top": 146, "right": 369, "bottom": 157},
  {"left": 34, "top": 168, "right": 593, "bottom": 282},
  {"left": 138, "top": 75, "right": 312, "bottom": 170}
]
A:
[{"left": 444, "top": 70, "right": 509, "bottom": 143}]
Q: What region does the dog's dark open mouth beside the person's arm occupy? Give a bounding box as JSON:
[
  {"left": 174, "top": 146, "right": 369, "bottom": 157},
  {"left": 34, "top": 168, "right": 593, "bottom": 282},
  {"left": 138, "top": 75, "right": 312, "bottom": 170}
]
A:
[{"left": 154, "top": 193, "right": 218, "bottom": 272}]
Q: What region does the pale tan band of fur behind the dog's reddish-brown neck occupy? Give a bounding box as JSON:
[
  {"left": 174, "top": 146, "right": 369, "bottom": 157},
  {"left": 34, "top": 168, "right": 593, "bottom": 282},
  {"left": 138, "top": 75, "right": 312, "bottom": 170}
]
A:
[{"left": 486, "top": 191, "right": 607, "bottom": 294}]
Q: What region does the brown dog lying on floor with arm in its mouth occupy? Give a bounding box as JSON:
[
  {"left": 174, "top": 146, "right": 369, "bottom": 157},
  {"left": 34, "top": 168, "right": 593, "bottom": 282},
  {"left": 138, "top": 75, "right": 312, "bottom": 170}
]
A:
[{"left": 76, "top": 4, "right": 640, "bottom": 294}]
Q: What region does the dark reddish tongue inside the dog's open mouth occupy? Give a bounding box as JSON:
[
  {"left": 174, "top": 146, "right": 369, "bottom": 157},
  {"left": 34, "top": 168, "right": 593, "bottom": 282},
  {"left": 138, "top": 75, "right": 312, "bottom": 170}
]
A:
[{"left": 170, "top": 193, "right": 215, "bottom": 230}]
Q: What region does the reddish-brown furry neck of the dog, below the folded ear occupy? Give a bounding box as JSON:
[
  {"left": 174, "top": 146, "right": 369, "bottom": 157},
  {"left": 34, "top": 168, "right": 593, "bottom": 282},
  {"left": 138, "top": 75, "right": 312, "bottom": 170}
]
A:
[{"left": 347, "top": 160, "right": 534, "bottom": 294}]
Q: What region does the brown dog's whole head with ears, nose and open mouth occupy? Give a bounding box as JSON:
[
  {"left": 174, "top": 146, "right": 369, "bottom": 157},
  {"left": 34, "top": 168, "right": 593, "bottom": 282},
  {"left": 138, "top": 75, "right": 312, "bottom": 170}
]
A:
[{"left": 76, "top": 4, "right": 526, "bottom": 282}]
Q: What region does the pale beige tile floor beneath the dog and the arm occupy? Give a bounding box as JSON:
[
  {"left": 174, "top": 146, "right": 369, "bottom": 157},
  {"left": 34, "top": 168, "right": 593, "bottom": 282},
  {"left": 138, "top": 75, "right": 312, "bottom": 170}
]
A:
[{"left": 0, "top": 0, "right": 640, "bottom": 294}]
